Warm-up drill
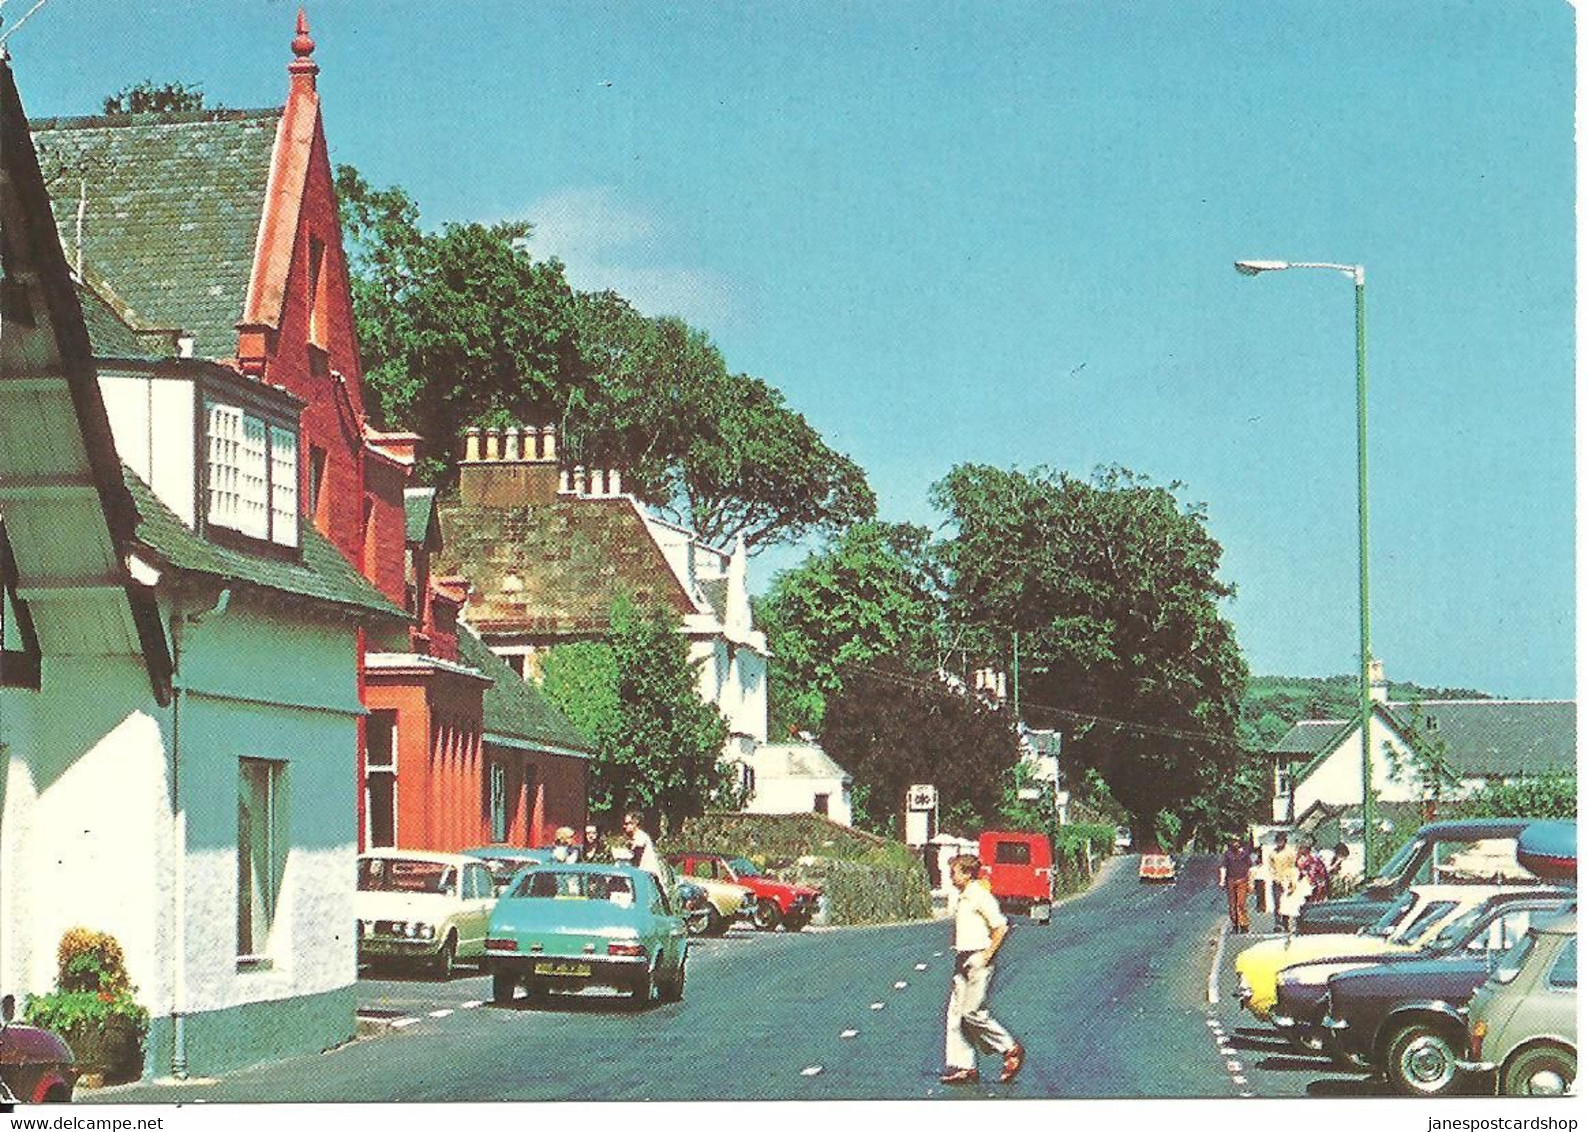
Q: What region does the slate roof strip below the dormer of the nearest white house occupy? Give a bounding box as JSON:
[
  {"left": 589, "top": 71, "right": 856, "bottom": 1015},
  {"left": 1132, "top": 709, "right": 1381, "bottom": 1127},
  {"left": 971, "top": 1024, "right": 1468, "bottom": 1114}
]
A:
[{"left": 122, "top": 465, "right": 408, "bottom": 621}]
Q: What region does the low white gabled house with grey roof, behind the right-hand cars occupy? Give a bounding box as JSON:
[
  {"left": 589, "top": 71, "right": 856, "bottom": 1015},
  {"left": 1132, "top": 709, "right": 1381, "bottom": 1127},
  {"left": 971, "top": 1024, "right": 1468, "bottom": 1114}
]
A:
[{"left": 1269, "top": 673, "right": 1577, "bottom": 824}]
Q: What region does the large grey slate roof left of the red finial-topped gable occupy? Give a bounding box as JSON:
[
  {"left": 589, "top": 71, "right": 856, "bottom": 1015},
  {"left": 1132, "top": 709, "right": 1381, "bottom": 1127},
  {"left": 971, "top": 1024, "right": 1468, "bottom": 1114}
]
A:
[{"left": 30, "top": 110, "right": 281, "bottom": 357}]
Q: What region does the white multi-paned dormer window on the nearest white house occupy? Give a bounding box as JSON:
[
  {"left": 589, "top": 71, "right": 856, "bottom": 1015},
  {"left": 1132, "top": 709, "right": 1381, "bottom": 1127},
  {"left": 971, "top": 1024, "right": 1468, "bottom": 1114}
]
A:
[{"left": 205, "top": 402, "right": 299, "bottom": 546}]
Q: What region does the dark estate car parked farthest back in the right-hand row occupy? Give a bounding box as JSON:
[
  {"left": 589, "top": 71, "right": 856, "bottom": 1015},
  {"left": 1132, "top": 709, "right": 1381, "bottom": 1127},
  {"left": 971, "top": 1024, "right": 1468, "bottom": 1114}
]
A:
[{"left": 1296, "top": 818, "right": 1537, "bottom": 935}]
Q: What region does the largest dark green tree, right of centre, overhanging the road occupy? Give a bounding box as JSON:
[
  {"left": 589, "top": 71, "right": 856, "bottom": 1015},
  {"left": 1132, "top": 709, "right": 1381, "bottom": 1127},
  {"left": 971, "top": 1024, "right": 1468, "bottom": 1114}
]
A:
[{"left": 934, "top": 465, "right": 1247, "bottom": 830}]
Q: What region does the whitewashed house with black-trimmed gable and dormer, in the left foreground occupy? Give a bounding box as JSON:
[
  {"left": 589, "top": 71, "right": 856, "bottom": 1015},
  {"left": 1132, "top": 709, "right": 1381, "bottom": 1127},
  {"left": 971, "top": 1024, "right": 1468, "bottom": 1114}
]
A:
[{"left": 0, "top": 60, "right": 407, "bottom": 1075}]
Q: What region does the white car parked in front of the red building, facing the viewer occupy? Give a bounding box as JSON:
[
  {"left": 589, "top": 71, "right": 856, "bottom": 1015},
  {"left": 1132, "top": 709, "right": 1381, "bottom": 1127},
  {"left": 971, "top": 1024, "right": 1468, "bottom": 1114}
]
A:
[{"left": 353, "top": 849, "right": 497, "bottom": 980}]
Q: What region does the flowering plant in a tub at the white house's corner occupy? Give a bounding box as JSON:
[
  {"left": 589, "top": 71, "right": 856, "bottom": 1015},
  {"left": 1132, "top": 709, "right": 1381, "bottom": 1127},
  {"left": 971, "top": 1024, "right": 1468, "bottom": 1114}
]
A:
[{"left": 27, "top": 927, "right": 149, "bottom": 1083}]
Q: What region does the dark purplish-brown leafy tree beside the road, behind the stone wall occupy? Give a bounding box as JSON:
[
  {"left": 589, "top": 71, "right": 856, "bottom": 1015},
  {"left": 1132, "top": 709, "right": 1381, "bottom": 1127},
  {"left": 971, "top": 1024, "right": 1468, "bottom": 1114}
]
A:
[{"left": 821, "top": 657, "right": 1019, "bottom": 837}]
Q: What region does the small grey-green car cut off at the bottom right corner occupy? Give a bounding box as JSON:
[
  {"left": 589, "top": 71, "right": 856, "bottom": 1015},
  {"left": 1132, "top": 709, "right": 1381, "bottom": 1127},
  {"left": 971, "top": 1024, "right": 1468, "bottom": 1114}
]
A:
[{"left": 1458, "top": 908, "right": 1577, "bottom": 1097}]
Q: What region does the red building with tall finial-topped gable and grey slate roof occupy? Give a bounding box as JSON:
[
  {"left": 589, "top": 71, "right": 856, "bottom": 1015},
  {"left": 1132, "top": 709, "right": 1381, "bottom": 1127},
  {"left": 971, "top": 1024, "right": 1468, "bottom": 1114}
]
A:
[{"left": 33, "top": 11, "right": 589, "bottom": 849}]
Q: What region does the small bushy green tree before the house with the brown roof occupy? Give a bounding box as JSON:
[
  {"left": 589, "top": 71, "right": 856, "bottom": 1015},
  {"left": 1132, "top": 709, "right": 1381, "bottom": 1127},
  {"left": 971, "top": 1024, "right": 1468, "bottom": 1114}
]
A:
[{"left": 542, "top": 597, "right": 732, "bottom": 829}]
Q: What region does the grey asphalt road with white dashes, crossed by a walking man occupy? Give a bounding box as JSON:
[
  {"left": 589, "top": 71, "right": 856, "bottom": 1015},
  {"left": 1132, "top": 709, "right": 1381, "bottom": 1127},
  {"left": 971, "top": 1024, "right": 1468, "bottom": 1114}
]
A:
[{"left": 79, "top": 857, "right": 1296, "bottom": 1103}]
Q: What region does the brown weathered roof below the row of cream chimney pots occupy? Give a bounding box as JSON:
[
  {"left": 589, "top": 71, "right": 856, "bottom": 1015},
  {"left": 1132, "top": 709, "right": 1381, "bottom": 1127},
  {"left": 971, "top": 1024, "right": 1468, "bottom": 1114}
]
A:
[{"left": 435, "top": 495, "right": 696, "bottom": 637}]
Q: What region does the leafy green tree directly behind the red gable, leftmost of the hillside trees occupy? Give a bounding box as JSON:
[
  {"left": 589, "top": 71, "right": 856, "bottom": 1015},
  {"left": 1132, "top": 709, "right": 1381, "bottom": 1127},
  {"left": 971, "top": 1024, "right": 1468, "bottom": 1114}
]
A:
[{"left": 337, "top": 165, "right": 591, "bottom": 483}]
